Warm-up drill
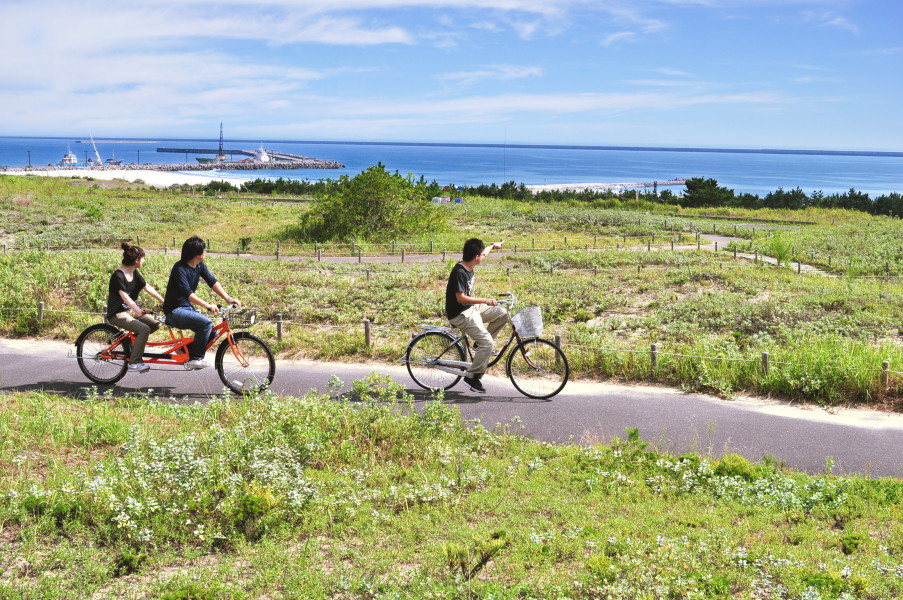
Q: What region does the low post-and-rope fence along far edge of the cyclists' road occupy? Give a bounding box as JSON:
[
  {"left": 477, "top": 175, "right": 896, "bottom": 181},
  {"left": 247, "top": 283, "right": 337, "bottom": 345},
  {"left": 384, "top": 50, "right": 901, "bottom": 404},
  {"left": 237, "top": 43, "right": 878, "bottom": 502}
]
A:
[{"left": 0, "top": 302, "right": 903, "bottom": 391}]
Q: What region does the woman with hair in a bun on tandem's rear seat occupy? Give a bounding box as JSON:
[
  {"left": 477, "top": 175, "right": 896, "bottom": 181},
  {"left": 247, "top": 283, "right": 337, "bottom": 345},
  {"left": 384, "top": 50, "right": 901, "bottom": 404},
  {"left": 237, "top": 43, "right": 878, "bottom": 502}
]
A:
[{"left": 107, "top": 242, "right": 163, "bottom": 373}]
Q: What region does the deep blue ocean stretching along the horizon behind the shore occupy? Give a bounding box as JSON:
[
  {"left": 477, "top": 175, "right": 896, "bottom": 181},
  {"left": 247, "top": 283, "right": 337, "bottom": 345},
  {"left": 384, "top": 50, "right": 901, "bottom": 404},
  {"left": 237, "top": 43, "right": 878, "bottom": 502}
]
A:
[{"left": 0, "top": 137, "right": 903, "bottom": 198}]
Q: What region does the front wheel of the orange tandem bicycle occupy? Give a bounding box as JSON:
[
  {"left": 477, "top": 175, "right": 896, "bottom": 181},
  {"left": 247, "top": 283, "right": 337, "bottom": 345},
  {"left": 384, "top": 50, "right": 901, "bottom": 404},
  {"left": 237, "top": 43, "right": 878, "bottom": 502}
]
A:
[{"left": 216, "top": 331, "right": 276, "bottom": 394}]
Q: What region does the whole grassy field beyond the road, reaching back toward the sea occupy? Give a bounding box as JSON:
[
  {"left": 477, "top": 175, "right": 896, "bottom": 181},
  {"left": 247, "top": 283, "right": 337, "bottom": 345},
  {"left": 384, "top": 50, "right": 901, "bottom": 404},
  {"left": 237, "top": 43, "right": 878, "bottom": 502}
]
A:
[{"left": 0, "top": 176, "right": 903, "bottom": 407}]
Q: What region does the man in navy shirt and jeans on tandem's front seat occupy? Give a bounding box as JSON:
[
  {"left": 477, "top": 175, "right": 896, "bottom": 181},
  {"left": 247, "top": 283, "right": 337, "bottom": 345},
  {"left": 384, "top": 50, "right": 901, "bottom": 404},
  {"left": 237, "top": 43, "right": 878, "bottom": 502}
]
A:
[{"left": 163, "top": 235, "right": 241, "bottom": 369}]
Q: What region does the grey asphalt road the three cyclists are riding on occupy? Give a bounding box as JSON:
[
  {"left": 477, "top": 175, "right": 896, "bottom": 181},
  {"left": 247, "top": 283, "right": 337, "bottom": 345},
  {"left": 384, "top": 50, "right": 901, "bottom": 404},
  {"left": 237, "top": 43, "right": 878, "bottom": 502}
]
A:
[{"left": 0, "top": 340, "right": 903, "bottom": 477}]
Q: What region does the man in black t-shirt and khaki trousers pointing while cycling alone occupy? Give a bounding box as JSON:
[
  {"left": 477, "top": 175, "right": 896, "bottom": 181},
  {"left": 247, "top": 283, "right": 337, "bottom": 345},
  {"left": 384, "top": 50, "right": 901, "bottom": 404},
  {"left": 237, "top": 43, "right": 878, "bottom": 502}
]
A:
[{"left": 445, "top": 238, "right": 508, "bottom": 392}]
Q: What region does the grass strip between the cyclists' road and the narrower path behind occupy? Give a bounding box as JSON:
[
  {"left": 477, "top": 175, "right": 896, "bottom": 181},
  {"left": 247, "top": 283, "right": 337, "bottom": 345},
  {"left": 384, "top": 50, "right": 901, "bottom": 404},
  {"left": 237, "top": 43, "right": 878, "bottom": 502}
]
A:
[{"left": 0, "top": 246, "right": 903, "bottom": 404}]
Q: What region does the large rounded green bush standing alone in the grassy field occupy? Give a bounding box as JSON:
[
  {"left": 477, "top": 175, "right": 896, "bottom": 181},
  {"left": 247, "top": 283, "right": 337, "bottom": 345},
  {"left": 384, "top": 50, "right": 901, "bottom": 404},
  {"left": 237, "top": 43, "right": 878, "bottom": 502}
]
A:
[{"left": 300, "top": 164, "right": 445, "bottom": 242}]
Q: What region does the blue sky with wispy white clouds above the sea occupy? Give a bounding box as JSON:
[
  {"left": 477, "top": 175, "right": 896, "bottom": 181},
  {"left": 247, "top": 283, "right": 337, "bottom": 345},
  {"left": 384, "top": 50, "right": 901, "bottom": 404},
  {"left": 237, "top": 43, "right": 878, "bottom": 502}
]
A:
[{"left": 0, "top": 0, "right": 903, "bottom": 151}]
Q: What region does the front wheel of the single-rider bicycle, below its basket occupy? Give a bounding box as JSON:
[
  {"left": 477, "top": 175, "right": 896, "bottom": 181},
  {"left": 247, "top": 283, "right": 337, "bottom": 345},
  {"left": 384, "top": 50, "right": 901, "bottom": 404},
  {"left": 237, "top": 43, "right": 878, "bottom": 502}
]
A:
[{"left": 506, "top": 338, "right": 571, "bottom": 399}]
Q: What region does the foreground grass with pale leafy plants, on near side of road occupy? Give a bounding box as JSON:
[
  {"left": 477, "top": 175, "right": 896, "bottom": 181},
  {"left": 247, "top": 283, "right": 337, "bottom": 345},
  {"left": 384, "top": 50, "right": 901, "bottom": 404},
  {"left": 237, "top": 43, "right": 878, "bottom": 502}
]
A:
[{"left": 0, "top": 384, "right": 903, "bottom": 599}]
